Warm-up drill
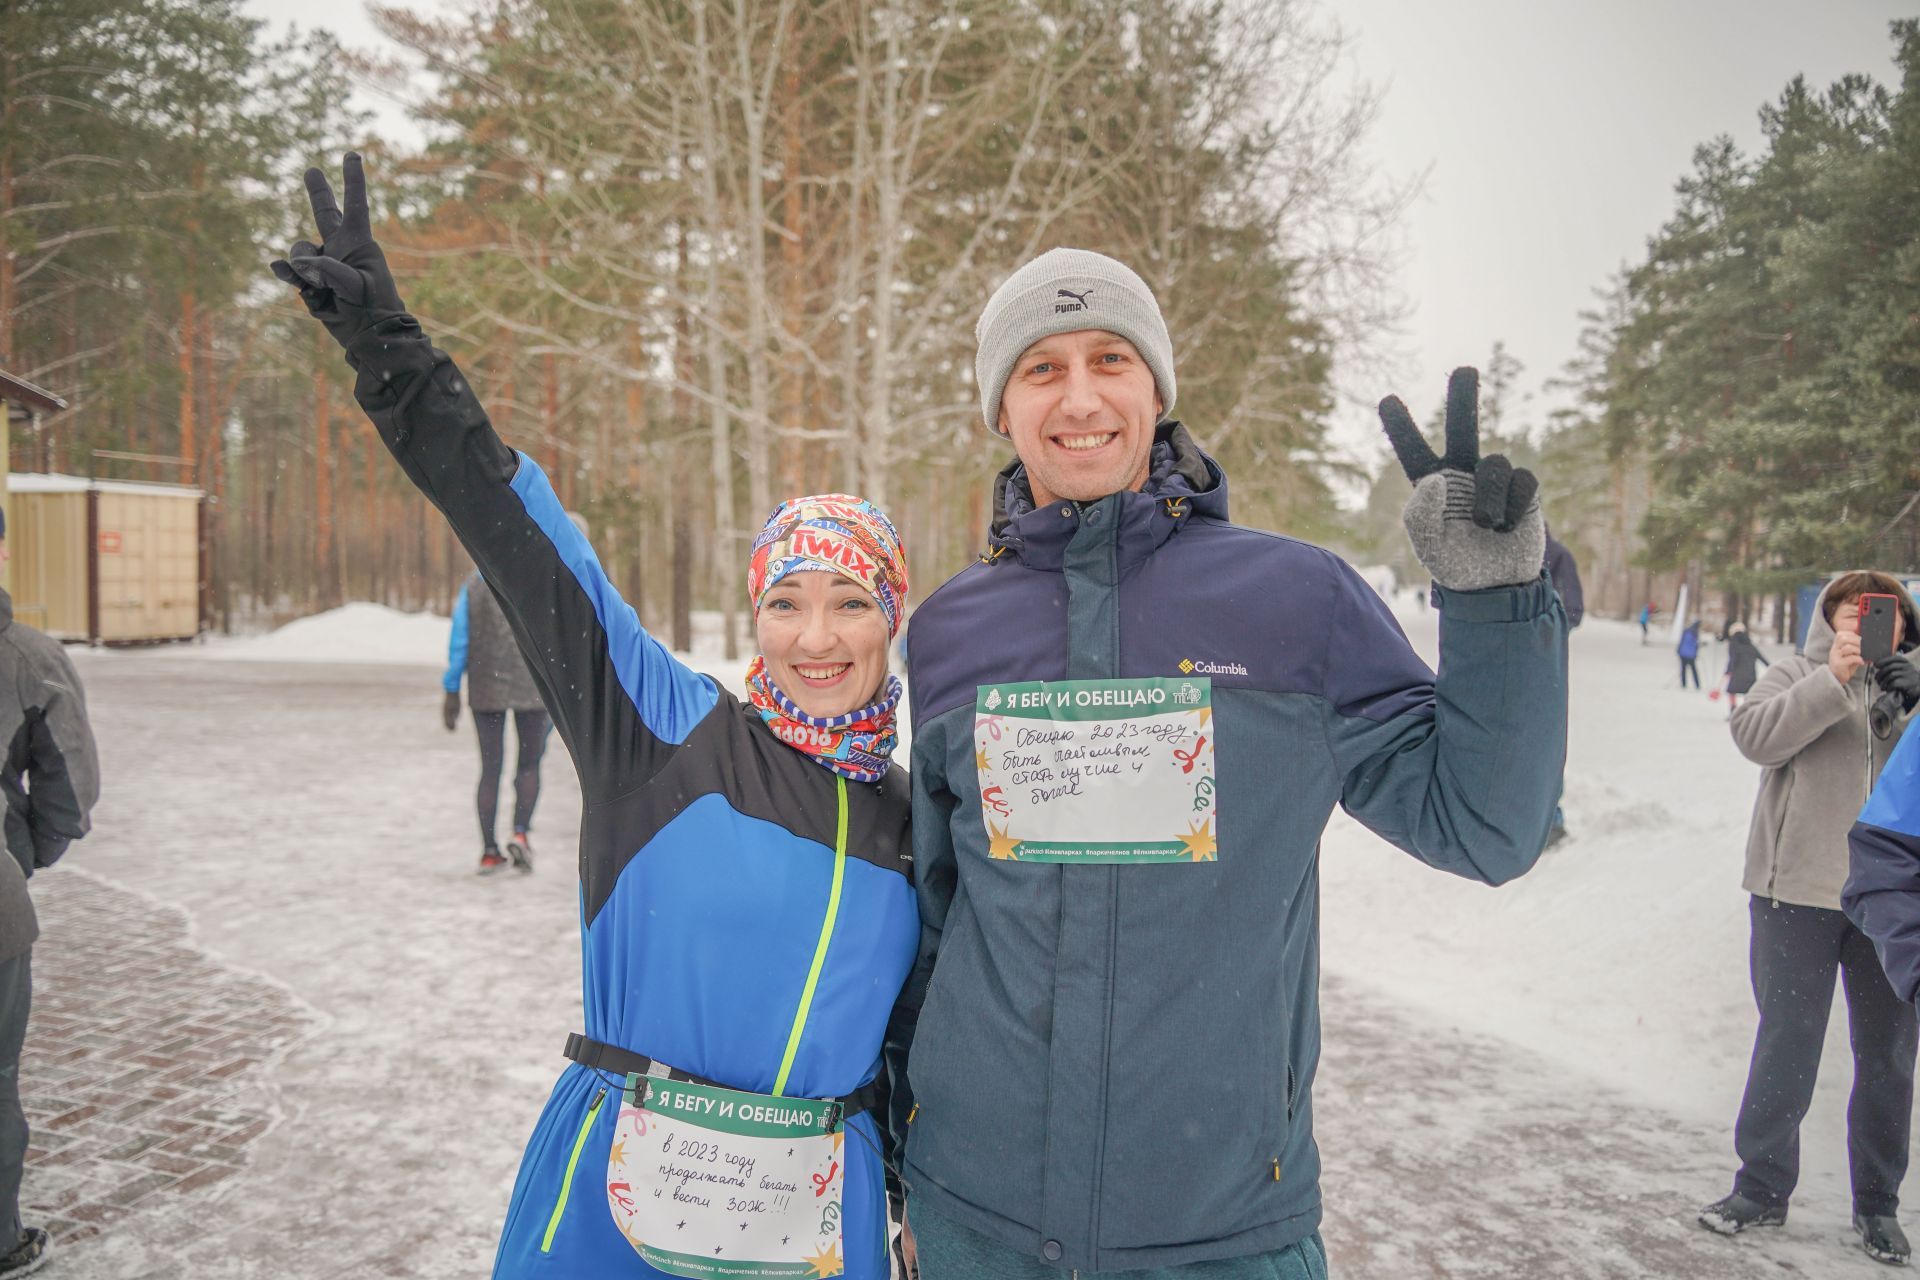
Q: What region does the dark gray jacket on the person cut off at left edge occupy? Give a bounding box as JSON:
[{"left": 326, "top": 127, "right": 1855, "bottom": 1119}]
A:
[{"left": 0, "top": 591, "right": 100, "bottom": 960}]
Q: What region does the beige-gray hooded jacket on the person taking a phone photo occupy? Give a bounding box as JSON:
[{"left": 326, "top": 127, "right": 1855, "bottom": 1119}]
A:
[{"left": 1732, "top": 591, "right": 1920, "bottom": 912}]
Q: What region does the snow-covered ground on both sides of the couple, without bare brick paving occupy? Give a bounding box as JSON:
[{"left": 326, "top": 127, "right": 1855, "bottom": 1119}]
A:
[{"left": 45, "top": 606, "right": 1904, "bottom": 1280}]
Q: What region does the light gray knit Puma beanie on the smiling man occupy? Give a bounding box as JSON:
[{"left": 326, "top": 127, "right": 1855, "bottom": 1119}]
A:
[{"left": 973, "top": 249, "right": 1173, "bottom": 432}]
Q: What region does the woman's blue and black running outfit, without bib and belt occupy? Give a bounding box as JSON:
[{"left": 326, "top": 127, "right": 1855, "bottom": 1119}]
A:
[{"left": 349, "top": 317, "right": 920, "bottom": 1280}]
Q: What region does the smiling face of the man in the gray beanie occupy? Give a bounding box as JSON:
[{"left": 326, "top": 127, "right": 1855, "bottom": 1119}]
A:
[{"left": 1000, "top": 328, "right": 1162, "bottom": 507}]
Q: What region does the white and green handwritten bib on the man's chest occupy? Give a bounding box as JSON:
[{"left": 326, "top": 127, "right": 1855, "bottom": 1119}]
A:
[{"left": 973, "top": 676, "right": 1219, "bottom": 864}]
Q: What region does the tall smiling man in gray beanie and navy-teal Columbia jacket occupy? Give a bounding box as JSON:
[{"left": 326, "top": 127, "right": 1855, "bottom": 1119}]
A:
[{"left": 889, "top": 249, "right": 1567, "bottom": 1280}]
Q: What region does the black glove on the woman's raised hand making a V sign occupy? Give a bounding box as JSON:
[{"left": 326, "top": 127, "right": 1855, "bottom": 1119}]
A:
[{"left": 273, "top": 152, "right": 407, "bottom": 347}]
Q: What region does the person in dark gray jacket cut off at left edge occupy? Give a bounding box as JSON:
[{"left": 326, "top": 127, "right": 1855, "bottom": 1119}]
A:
[{"left": 0, "top": 510, "right": 100, "bottom": 1280}]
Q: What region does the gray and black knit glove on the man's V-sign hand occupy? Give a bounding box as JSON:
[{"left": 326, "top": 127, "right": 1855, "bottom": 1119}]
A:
[{"left": 1380, "top": 368, "right": 1548, "bottom": 591}]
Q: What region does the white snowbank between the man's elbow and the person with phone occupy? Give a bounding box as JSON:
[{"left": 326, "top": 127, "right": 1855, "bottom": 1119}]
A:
[{"left": 1323, "top": 612, "right": 1812, "bottom": 1143}]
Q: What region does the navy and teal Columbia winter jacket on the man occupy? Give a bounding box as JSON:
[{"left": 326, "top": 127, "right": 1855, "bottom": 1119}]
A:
[{"left": 889, "top": 422, "right": 1567, "bottom": 1270}]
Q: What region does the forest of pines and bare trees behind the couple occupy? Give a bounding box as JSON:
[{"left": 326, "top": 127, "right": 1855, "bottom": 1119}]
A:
[{"left": 0, "top": 0, "right": 1920, "bottom": 649}]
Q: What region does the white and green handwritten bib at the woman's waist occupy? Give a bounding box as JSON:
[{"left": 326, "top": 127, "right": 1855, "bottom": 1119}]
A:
[{"left": 607, "top": 1075, "right": 847, "bottom": 1280}]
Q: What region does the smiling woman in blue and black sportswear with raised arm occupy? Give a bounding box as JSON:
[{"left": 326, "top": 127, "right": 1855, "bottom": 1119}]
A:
[{"left": 273, "top": 155, "right": 920, "bottom": 1280}]
